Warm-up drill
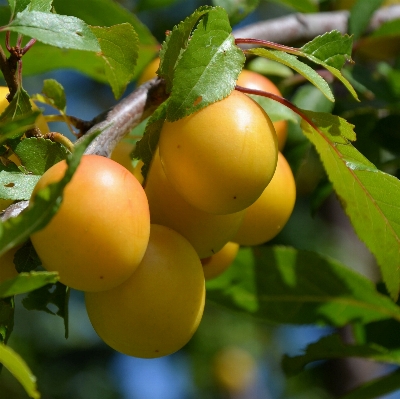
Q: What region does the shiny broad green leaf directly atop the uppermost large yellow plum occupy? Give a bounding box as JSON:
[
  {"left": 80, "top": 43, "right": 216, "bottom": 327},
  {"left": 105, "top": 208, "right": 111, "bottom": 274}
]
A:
[{"left": 167, "top": 8, "right": 245, "bottom": 121}]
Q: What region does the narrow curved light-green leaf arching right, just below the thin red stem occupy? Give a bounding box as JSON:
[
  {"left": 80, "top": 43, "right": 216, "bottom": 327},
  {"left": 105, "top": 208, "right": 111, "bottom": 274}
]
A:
[{"left": 246, "top": 48, "right": 335, "bottom": 102}]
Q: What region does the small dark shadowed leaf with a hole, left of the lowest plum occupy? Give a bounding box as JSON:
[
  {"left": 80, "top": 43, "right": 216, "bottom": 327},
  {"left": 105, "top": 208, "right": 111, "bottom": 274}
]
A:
[{"left": 22, "top": 282, "right": 70, "bottom": 338}]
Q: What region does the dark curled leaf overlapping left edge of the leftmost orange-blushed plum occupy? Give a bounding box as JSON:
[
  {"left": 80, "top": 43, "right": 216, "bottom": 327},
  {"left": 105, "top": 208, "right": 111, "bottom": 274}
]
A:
[{"left": 0, "top": 134, "right": 97, "bottom": 256}]
